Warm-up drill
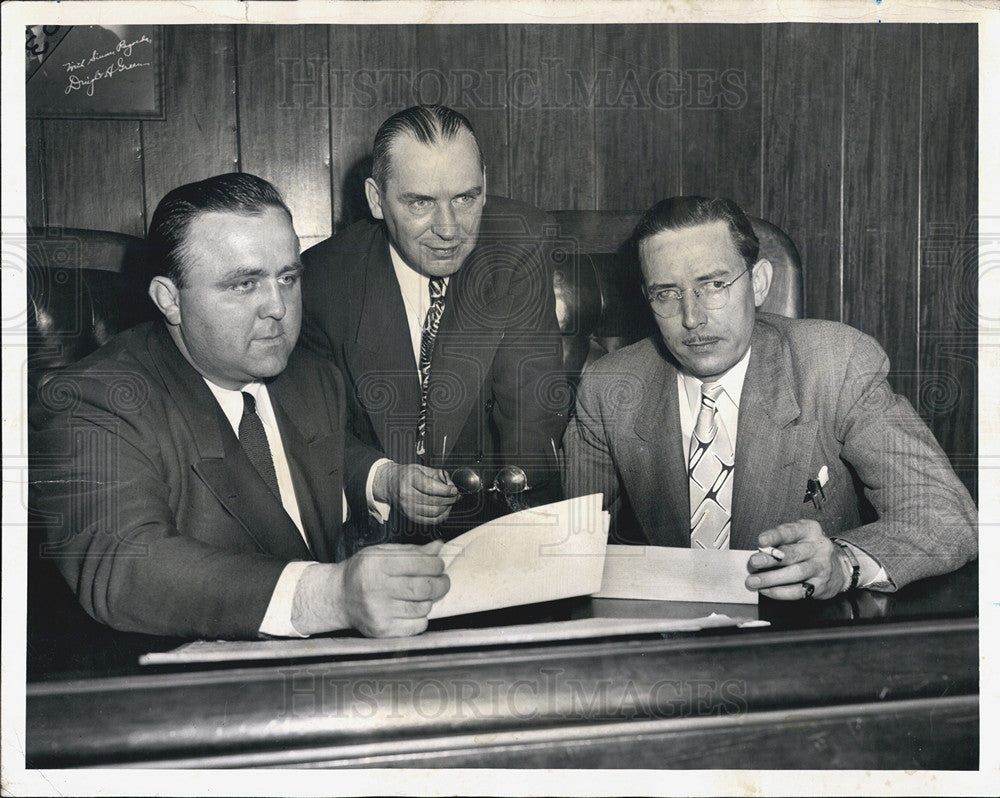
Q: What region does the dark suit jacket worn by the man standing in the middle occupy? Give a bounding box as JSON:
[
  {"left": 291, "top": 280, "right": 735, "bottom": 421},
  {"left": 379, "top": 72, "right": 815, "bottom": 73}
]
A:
[{"left": 300, "top": 197, "right": 570, "bottom": 540}]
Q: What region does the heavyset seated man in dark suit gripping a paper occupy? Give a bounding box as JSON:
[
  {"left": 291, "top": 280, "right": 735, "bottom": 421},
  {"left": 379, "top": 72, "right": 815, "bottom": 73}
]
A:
[{"left": 31, "top": 174, "right": 448, "bottom": 638}]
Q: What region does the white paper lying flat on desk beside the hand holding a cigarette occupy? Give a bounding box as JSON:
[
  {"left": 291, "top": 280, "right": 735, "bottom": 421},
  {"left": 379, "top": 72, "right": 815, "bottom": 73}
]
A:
[{"left": 595, "top": 546, "right": 758, "bottom": 604}]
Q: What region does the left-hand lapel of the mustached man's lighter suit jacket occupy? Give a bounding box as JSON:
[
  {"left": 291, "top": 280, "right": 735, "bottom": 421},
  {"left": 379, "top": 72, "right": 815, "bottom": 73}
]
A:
[{"left": 633, "top": 348, "right": 691, "bottom": 546}]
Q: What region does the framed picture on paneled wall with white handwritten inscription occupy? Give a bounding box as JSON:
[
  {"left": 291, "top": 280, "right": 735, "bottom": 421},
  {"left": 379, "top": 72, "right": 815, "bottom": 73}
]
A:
[{"left": 24, "top": 25, "right": 163, "bottom": 119}]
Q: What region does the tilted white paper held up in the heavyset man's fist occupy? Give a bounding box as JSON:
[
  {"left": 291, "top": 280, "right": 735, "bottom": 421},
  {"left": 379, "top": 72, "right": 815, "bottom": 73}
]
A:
[{"left": 428, "top": 493, "right": 608, "bottom": 618}]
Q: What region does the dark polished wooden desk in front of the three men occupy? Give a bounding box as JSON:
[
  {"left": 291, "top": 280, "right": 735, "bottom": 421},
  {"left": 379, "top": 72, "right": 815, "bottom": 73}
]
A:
[{"left": 21, "top": 563, "right": 979, "bottom": 769}]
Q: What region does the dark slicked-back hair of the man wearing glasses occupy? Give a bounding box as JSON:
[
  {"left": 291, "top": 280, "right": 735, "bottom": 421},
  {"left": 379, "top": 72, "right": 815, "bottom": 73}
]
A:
[{"left": 632, "top": 197, "right": 760, "bottom": 269}]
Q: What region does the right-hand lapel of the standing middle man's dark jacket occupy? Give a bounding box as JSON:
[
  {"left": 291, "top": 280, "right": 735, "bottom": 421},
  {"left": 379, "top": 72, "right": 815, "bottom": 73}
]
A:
[{"left": 427, "top": 244, "right": 510, "bottom": 464}]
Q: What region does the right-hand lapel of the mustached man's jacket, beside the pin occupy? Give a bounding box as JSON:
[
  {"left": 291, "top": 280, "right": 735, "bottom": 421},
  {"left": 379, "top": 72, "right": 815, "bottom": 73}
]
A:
[{"left": 731, "top": 321, "right": 817, "bottom": 549}]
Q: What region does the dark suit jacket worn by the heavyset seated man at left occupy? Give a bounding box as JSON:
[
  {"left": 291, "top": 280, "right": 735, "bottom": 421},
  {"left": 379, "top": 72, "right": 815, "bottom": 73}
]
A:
[{"left": 31, "top": 322, "right": 345, "bottom": 638}]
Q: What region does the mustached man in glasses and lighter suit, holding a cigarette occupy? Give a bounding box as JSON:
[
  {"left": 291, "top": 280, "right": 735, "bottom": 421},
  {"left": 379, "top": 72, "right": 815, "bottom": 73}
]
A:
[{"left": 566, "top": 197, "right": 977, "bottom": 599}]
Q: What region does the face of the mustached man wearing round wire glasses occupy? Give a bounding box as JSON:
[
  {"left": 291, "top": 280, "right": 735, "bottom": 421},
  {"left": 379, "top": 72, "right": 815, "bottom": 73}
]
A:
[{"left": 639, "top": 221, "right": 771, "bottom": 381}]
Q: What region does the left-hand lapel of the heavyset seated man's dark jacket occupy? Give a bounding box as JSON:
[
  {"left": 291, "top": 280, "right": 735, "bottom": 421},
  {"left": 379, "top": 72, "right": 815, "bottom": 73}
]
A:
[{"left": 150, "top": 324, "right": 309, "bottom": 559}]
